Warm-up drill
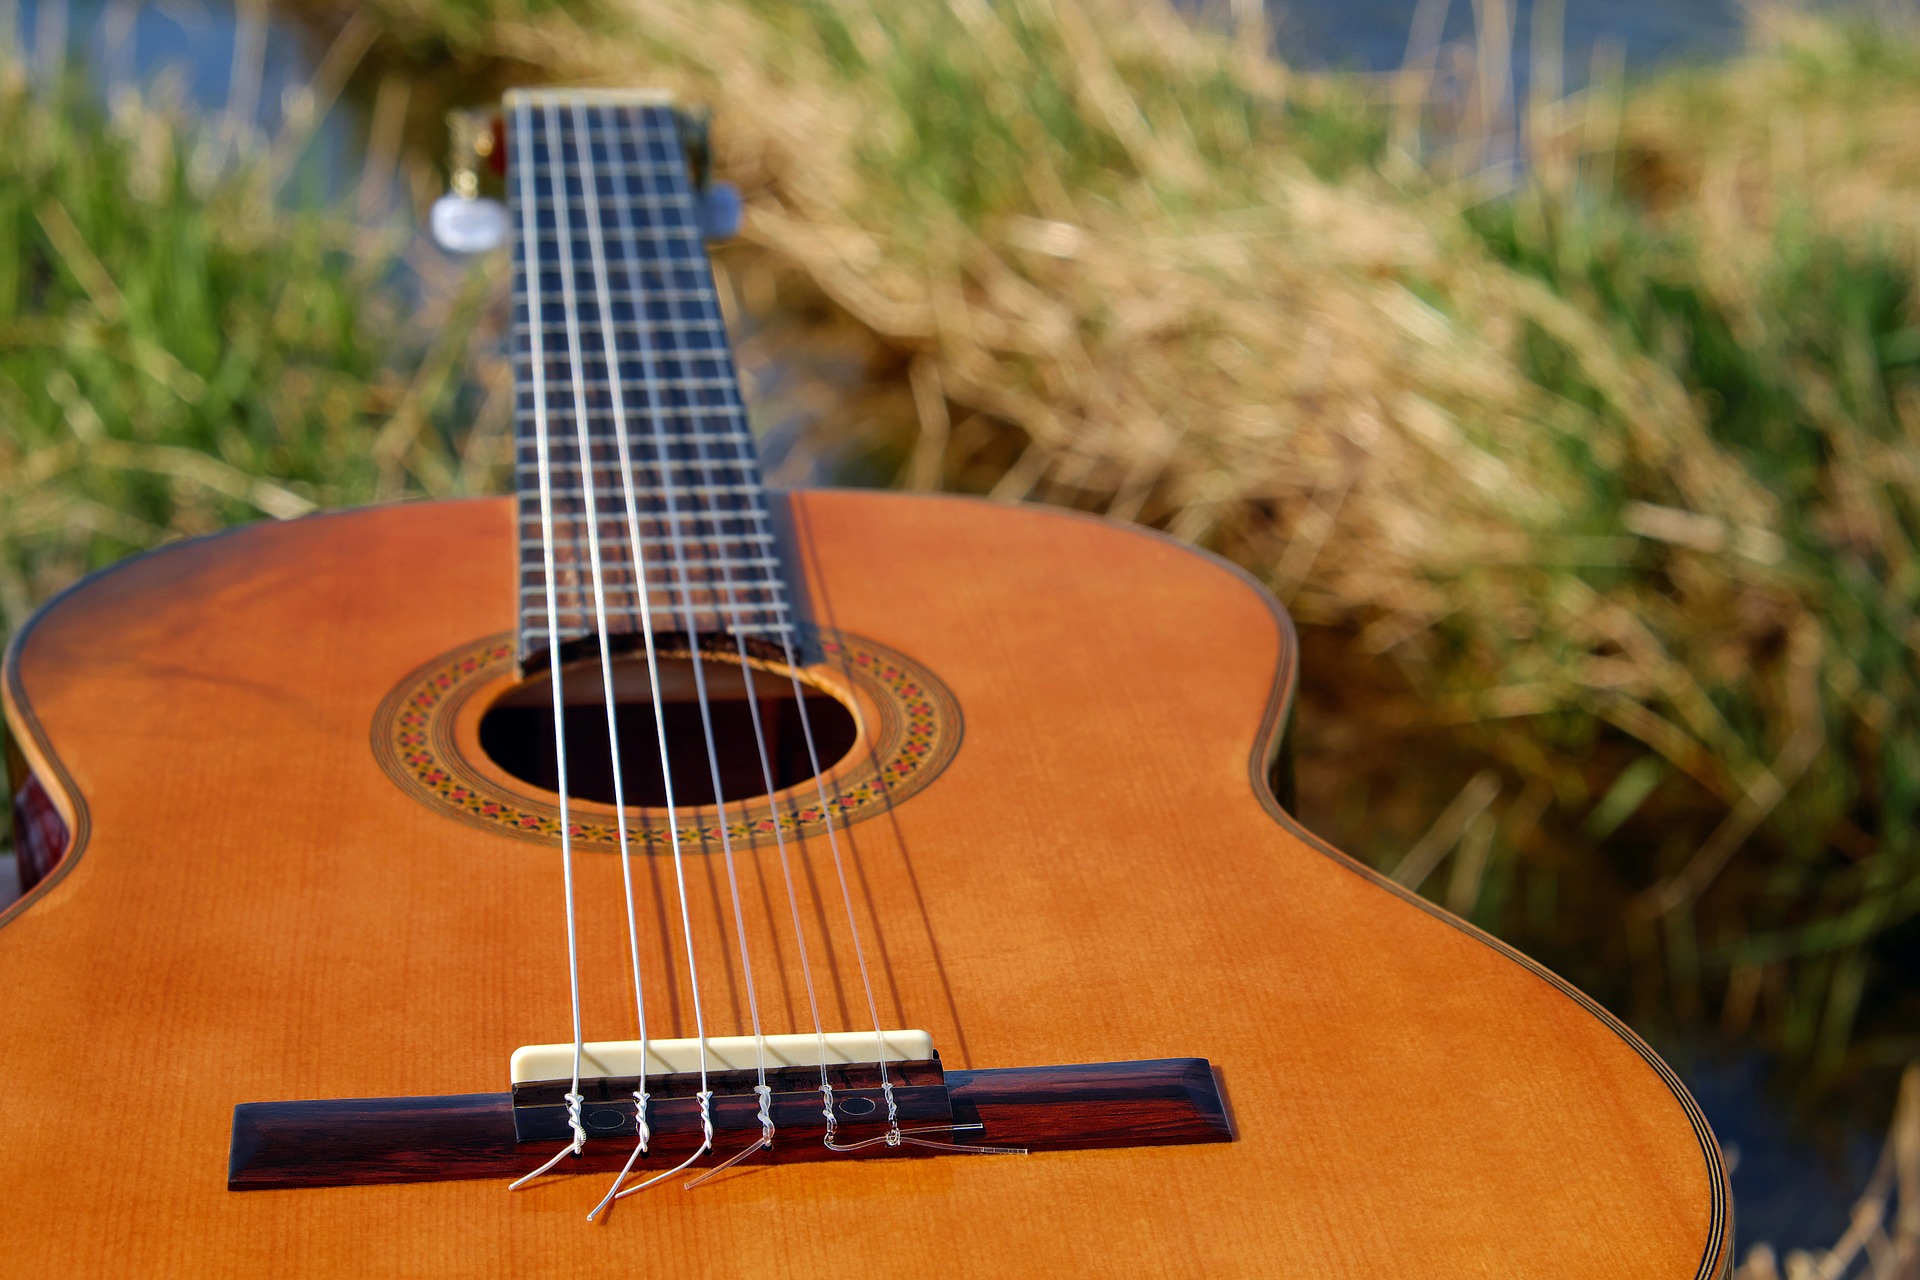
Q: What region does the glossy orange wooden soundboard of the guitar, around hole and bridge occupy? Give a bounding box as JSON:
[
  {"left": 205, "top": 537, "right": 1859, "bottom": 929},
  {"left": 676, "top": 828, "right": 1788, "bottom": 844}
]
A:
[{"left": 0, "top": 491, "right": 1730, "bottom": 1280}]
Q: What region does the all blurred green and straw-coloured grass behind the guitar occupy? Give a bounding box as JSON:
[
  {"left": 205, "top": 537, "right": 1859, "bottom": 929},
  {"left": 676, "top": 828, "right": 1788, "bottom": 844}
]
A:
[{"left": 0, "top": 0, "right": 1920, "bottom": 1280}]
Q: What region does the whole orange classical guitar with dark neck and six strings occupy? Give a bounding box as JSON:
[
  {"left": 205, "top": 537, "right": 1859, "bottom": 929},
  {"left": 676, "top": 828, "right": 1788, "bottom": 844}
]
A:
[{"left": 0, "top": 90, "right": 1730, "bottom": 1280}]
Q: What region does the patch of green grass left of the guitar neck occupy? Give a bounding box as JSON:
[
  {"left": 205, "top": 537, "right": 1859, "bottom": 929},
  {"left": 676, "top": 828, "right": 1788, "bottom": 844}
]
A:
[{"left": 0, "top": 23, "right": 495, "bottom": 631}]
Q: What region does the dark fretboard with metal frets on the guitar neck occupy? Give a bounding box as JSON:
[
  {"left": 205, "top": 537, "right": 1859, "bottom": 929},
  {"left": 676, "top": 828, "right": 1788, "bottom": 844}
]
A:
[{"left": 507, "top": 90, "right": 791, "bottom": 662}]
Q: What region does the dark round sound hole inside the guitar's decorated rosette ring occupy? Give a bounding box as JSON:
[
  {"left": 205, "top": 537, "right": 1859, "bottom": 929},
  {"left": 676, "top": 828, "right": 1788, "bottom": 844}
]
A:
[{"left": 480, "top": 656, "right": 856, "bottom": 808}]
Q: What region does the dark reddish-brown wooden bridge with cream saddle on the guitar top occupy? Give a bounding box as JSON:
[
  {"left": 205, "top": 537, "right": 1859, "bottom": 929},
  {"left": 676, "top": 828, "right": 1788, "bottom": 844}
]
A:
[{"left": 227, "top": 1031, "right": 1233, "bottom": 1192}]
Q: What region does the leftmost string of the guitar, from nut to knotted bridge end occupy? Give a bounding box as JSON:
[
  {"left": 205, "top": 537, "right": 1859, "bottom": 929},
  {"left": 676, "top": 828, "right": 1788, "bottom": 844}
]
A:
[{"left": 507, "top": 104, "right": 588, "bottom": 1192}]
